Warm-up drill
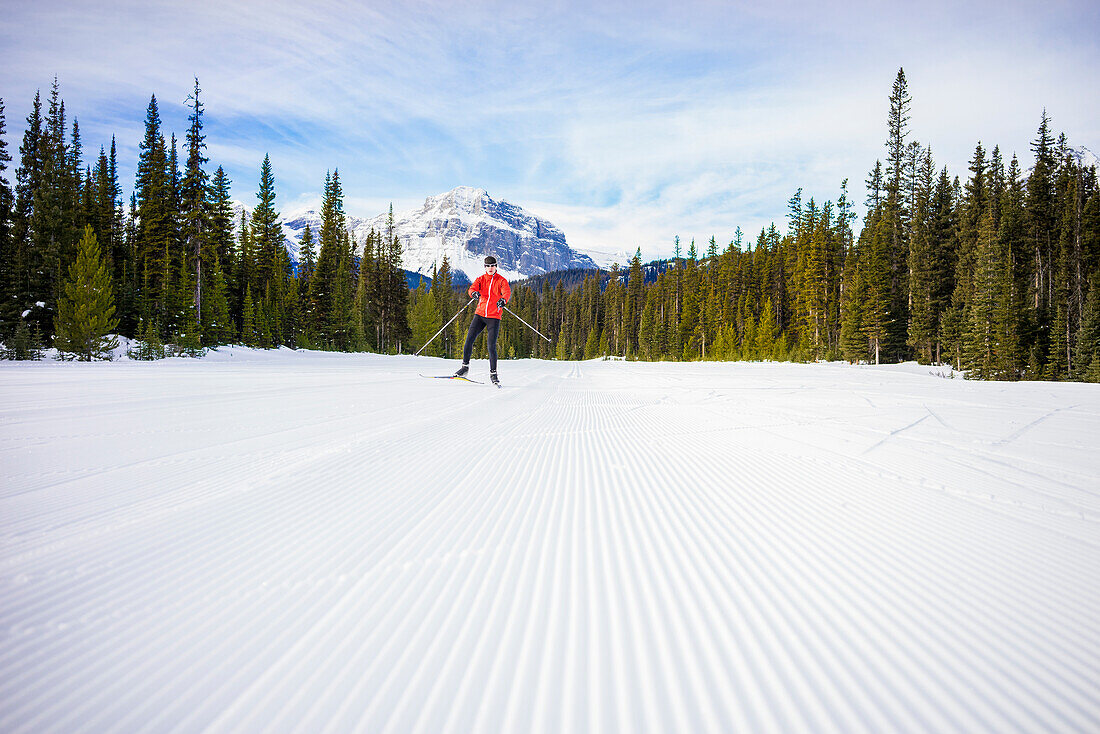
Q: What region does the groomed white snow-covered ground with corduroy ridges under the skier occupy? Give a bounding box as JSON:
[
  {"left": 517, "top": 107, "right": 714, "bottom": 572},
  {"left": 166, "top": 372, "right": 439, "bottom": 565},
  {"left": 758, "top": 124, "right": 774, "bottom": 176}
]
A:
[{"left": 0, "top": 349, "right": 1100, "bottom": 733}]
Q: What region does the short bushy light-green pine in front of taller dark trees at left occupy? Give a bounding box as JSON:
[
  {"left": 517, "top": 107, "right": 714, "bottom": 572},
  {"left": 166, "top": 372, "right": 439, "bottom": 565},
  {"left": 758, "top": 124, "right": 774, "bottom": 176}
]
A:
[{"left": 54, "top": 227, "right": 118, "bottom": 361}]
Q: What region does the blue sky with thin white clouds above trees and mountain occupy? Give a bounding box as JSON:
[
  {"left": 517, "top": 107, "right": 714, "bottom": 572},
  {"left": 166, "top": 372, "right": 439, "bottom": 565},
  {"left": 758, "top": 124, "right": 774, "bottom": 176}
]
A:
[{"left": 0, "top": 0, "right": 1100, "bottom": 263}]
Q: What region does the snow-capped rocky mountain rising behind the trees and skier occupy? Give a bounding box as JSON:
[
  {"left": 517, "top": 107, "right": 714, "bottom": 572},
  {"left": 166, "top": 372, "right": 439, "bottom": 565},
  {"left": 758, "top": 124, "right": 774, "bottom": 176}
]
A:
[{"left": 275, "top": 186, "right": 596, "bottom": 282}]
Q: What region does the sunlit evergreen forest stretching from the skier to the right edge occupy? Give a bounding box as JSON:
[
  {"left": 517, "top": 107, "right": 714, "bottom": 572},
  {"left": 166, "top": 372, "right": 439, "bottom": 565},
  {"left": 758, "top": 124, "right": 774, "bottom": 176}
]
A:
[{"left": 477, "top": 70, "right": 1100, "bottom": 381}]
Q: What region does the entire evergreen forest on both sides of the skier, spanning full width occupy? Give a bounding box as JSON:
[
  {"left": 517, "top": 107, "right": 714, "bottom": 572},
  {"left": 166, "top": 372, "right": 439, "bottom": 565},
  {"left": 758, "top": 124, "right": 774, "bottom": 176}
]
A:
[{"left": 0, "top": 70, "right": 1100, "bottom": 381}]
